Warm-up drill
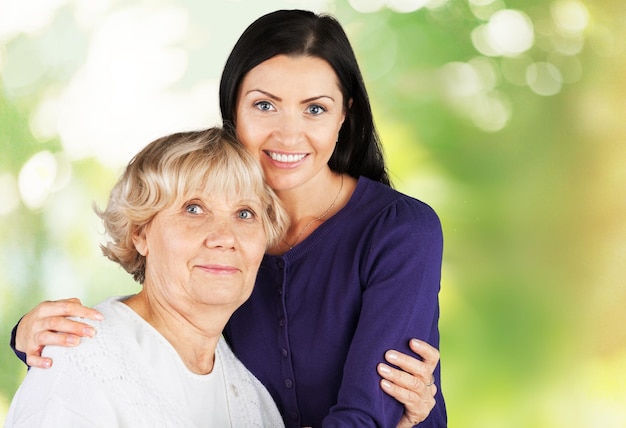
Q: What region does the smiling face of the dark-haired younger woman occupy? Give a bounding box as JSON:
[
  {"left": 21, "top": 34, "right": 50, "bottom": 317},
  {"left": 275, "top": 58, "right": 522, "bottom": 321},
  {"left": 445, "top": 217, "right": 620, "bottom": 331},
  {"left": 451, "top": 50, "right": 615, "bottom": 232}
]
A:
[{"left": 236, "top": 55, "right": 345, "bottom": 191}]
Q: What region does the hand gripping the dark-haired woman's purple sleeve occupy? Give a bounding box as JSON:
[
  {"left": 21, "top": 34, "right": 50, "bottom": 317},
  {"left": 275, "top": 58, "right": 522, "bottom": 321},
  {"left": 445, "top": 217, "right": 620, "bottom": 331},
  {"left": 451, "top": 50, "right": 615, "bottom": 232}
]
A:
[{"left": 377, "top": 339, "right": 439, "bottom": 428}]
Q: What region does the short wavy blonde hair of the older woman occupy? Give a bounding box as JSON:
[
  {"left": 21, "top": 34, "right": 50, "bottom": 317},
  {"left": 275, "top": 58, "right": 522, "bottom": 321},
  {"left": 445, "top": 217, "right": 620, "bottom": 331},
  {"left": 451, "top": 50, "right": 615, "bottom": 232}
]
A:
[{"left": 94, "top": 128, "right": 288, "bottom": 284}]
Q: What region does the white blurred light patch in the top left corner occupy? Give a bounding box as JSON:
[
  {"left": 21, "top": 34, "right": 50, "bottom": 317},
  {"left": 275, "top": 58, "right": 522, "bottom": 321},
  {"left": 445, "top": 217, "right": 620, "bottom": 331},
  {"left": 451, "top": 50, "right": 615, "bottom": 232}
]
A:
[{"left": 0, "top": 0, "right": 68, "bottom": 41}]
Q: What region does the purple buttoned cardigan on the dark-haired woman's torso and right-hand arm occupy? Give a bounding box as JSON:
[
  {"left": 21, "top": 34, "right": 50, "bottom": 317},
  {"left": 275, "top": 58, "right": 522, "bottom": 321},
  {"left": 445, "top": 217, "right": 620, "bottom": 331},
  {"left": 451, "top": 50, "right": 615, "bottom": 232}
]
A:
[{"left": 225, "top": 177, "right": 446, "bottom": 428}]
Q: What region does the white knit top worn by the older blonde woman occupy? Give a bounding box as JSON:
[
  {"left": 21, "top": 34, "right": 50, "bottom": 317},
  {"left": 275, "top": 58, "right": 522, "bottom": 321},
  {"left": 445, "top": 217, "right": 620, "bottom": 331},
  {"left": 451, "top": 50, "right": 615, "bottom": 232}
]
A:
[{"left": 5, "top": 298, "right": 284, "bottom": 428}]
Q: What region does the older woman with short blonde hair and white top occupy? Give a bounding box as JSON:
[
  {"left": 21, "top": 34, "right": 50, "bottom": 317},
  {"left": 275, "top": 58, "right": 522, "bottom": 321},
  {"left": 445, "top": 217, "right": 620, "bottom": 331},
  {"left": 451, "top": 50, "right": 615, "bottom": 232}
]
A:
[{"left": 6, "top": 128, "right": 286, "bottom": 427}]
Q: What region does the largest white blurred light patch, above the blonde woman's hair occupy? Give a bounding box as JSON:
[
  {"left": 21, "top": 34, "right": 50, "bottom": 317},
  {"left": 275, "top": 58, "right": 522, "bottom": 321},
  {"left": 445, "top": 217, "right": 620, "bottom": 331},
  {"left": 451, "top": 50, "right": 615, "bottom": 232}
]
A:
[{"left": 53, "top": 6, "right": 214, "bottom": 167}]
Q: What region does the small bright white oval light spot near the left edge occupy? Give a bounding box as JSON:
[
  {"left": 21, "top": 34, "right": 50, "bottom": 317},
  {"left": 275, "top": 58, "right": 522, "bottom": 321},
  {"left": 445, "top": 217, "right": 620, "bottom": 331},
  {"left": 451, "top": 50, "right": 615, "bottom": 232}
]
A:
[{"left": 18, "top": 151, "right": 57, "bottom": 209}]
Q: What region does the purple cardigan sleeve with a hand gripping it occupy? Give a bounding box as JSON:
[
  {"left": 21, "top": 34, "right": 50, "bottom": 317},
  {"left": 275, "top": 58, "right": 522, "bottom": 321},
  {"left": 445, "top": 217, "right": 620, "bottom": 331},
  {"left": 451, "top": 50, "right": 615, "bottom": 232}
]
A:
[{"left": 323, "top": 198, "right": 447, "bottom": 428}]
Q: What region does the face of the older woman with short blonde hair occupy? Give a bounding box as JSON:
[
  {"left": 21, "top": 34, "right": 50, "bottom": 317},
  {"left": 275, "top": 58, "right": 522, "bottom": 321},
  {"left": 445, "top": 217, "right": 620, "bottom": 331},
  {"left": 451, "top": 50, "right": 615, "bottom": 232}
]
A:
[{"left": 135, "top": 192, "right": 267, "bottom": 311}]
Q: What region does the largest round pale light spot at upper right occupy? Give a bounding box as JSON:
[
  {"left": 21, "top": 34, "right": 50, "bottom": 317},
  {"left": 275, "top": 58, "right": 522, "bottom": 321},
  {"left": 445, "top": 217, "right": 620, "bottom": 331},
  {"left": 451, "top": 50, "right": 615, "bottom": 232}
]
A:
[{"left": 484, "top": 9, "right": 534, "bottom": 56}]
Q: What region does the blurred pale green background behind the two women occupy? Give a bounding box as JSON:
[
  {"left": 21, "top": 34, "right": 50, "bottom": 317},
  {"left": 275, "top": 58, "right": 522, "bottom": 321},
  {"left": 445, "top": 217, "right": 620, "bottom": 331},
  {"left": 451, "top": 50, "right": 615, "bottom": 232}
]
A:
[{"left": 0, "top": 0, "right": 626, "bottom": 428}]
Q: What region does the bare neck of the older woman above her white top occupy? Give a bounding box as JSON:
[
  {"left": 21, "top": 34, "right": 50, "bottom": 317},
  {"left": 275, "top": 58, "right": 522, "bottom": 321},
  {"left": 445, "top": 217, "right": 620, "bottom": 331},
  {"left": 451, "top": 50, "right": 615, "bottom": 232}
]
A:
[{"left": 124, "top": 291, "right": 231, "bottom": 374}]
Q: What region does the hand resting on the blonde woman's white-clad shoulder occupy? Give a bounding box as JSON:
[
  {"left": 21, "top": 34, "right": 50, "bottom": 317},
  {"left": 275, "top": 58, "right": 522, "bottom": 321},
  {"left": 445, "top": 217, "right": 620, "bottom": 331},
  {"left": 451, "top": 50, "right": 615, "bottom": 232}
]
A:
[{"left": 15, "top": 298, "right": 103, "bottom": 369}]
